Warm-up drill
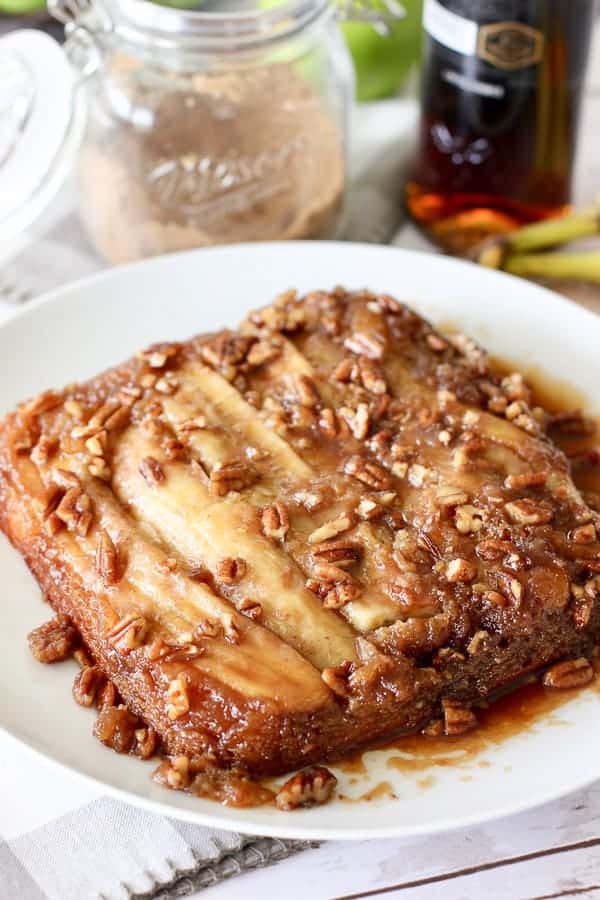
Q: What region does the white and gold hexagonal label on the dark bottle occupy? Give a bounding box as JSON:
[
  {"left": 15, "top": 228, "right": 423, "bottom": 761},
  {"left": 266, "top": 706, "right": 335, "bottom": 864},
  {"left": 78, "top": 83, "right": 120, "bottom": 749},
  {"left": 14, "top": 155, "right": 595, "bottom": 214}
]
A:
[{"left": 423, "top": 0, "right": 544, "bottom": 71}]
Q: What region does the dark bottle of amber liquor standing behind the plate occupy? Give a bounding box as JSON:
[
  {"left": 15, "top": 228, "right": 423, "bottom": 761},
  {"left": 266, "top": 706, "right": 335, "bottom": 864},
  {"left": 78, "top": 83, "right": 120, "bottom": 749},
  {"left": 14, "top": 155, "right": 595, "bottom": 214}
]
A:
[{"left": 406, "top": 0, "right": 593, "bottom": 253}]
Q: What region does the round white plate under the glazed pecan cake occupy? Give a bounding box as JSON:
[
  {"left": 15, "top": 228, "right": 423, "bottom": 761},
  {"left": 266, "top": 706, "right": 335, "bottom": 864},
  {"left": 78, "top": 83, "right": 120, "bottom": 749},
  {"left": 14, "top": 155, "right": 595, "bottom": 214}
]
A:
[{"left": 0, "top": 243, "right": 600, "bottom": 839}]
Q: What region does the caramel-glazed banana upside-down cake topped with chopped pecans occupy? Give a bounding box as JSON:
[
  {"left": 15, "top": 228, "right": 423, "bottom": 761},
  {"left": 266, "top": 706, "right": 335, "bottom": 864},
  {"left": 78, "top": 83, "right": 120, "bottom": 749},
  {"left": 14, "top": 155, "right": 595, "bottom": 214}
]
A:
[{"left": 0, "top": 288, "right": 600, "bottom": 807}]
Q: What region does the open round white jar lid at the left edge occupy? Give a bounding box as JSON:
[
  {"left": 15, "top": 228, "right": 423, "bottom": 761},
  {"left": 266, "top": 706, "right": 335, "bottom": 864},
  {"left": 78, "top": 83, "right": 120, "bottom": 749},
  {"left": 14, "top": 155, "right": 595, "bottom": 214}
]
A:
[{"left": 0, "top": 30, "right": 83, "bottom": 241}]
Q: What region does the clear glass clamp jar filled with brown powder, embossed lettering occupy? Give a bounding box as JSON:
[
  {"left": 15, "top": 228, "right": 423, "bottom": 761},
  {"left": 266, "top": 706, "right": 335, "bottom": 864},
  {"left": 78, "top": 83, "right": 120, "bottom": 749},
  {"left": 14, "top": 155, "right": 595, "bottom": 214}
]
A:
[{"left": 0, "top": 0, "right": 353, "bottom": 263}]
